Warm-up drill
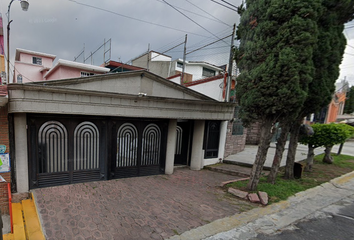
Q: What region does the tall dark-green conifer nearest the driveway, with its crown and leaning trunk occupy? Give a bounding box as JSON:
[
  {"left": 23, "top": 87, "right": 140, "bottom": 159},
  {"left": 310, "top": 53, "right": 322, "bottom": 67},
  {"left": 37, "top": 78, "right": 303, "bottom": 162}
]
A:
[{"left": 235, "top": 0, "right": 322, "bottom": 191}]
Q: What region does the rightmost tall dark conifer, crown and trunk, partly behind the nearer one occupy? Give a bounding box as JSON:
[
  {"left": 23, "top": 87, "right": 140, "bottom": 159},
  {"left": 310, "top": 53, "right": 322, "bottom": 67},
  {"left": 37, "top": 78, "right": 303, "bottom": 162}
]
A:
[{"left": 285, "top": 0, "right": 354, "bottom": 179}]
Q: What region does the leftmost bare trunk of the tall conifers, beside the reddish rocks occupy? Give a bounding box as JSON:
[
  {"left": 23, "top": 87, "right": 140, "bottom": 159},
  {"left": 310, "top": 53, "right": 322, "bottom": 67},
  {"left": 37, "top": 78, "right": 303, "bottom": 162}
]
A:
[{"left": 247, "top": 119, "right": 273, "bottom": 191}]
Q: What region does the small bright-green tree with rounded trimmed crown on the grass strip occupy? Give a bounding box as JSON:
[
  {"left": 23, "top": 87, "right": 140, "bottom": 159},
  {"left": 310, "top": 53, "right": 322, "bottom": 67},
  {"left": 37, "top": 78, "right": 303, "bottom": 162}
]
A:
[{"left": 299, "top": 123, "right": 354, "bottom": 168}]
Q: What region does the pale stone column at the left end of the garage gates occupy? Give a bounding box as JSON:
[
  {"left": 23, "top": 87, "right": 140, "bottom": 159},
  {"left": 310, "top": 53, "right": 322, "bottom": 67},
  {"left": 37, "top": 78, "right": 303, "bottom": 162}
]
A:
[{"left": 14, "top": 113, "right": 29, "bottom": 193}]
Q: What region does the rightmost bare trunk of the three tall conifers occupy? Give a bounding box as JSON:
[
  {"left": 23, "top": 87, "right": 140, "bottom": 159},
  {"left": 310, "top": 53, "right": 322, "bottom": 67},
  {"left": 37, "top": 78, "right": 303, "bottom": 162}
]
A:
[{"left": 284, "top": 118, "right": 302, "bottom": 179}]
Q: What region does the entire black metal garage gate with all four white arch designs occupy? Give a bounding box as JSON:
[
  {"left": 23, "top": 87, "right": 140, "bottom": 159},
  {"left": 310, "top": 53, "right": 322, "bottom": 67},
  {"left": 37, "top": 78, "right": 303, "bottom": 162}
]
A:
[{"left": 27, "top": 115, "right": 167, "bottom": 189}]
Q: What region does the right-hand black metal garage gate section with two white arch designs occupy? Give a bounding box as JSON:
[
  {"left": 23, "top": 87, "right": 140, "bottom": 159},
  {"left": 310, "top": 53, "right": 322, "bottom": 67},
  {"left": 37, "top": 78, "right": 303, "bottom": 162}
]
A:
[{"left": 111, "top": 120, "right": 167, "bottom": 178}]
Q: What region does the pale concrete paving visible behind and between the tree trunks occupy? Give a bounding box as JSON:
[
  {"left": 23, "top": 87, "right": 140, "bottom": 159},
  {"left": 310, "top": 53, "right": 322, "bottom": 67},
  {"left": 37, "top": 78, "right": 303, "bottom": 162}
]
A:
[{"left": 224, "top": 141, "right": 354, "bottom": 169}]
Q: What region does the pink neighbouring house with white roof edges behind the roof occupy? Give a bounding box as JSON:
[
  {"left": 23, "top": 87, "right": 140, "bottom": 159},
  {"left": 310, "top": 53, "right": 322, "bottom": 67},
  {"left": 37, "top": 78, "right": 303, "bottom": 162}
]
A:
[{"left": 13, "top": 48, "right": 110, "bottom": 83}]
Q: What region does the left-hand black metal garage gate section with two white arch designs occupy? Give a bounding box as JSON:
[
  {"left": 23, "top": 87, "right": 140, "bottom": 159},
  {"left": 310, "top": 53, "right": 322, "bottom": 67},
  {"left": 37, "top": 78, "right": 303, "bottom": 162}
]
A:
[{"left": 27, "top": 115, "right": 106, "bottom": 189}]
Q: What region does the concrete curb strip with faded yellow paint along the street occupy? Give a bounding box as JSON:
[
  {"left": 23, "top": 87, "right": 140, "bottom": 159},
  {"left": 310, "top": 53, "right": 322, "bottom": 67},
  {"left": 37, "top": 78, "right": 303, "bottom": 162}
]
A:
[{"left": 168, "top": 171, "right": 354, "bottom": 240}]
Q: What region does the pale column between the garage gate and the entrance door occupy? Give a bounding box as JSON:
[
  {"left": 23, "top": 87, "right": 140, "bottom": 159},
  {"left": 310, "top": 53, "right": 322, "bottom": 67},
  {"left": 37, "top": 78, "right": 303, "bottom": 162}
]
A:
[{"left": 165, "top": 119, "right": 177, "bottom": 174}]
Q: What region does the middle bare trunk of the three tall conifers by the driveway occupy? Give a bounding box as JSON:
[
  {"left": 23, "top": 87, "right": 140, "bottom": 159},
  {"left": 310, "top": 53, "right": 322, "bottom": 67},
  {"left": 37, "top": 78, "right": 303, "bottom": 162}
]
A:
[{"left": 267, "top": 122, "right": 290, "bottom": 184}]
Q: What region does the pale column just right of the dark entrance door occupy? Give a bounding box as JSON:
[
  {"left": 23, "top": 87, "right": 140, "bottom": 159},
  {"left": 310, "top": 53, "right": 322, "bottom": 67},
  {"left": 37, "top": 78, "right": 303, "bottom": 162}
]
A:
[{"left": 191, "top": 120, "right": 205, "bottom": 170}]
